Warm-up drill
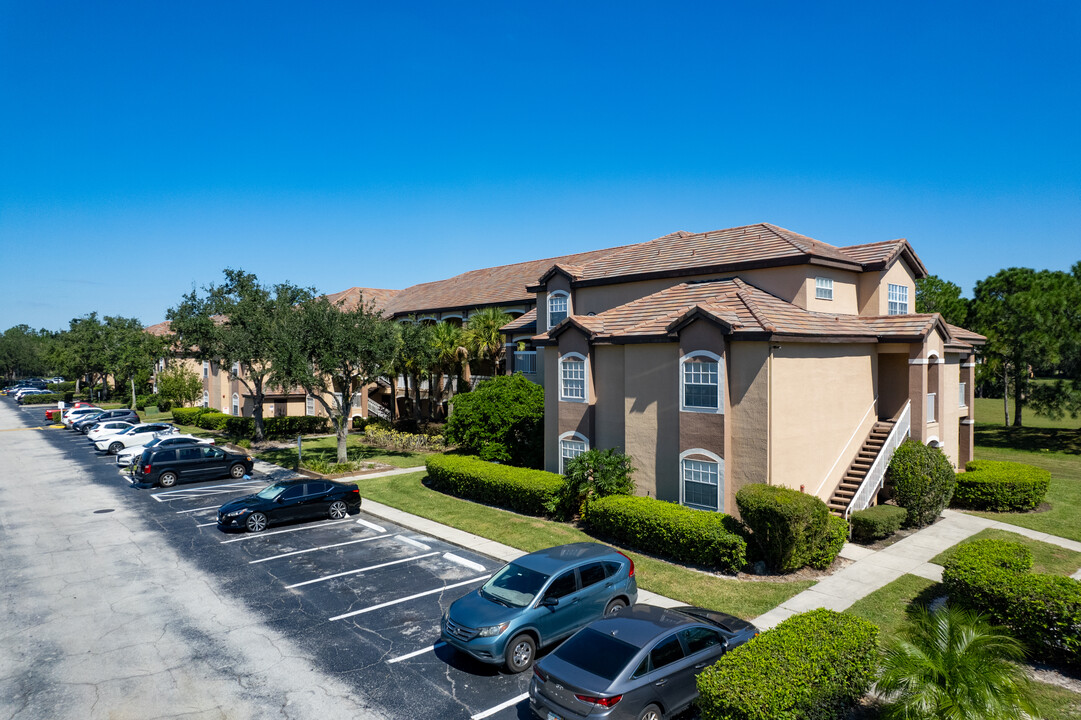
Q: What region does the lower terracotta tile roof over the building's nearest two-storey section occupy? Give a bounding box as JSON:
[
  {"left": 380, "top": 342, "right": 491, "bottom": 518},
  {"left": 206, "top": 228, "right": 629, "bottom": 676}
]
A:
[{"left": 538, "top": 278, "right": 977, "bottom": 341}]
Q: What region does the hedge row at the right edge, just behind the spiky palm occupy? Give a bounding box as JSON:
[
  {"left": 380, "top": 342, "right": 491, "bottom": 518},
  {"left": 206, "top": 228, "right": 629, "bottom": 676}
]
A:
[{"left": 943, "top": 539, "right": 1081, "bottom": 665}]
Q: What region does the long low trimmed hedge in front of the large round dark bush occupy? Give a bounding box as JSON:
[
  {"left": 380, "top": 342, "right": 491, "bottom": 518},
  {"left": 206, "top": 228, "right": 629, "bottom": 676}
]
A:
[{"left": 425, "top": 455, "right": 563, "bottom": 516}]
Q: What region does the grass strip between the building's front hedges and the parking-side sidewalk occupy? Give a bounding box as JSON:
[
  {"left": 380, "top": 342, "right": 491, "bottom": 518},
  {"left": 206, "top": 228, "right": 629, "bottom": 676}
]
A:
[{"left": 357, "top": 472, "right": 814, "bottom": 619}]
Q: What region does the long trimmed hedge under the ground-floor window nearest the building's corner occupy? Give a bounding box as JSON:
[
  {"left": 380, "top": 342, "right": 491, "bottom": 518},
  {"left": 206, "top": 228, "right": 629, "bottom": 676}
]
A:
[{"left": 582, "top": 495, "right": 747, "bottom": 573}]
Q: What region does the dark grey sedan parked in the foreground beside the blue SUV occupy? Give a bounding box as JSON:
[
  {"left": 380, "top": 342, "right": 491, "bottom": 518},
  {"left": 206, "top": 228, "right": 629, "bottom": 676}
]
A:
[{"left": 530, "top": 605, "right": 758, "bottom": 720}]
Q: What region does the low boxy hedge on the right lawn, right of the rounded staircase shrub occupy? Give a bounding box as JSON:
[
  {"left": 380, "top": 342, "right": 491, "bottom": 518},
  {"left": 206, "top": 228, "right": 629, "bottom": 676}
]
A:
[{"left": 950, "top": 461, "right": 1051, "bottom": 512}]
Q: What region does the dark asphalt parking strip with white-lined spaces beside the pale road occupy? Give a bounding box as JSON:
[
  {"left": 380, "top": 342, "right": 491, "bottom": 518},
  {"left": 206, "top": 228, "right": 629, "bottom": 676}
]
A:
[{"left": 0, "top": 400, "right": 540, "bottom": 720}]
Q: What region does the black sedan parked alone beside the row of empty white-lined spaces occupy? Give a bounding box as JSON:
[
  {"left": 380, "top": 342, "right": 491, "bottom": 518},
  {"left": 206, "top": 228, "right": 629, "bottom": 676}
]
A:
[{"left": 217, "top": 478, "right": 360, "bottom": 533}]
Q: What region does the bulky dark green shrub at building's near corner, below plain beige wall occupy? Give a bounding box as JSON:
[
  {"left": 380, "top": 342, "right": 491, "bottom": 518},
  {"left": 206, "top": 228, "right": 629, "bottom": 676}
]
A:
[{"left": 736, "top": 483, "right": 849, "bottom": 573}]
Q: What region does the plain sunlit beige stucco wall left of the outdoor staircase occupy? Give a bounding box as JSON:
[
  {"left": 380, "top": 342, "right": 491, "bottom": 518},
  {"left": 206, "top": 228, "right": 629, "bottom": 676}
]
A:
[{"left": 770, "top": 343, "right": 878, "bottom": 501}]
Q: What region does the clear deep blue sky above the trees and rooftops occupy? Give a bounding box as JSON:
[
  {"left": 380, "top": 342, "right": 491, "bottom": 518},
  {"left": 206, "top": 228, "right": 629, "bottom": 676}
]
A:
[{"left": 0, "top": 0, "right": 1081, "bottom": 330}]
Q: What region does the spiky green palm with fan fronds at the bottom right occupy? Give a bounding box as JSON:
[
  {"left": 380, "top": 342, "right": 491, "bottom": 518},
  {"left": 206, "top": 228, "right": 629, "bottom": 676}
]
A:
[{"left": 876, "top": 605, "right": 1039, "bottom": 720}]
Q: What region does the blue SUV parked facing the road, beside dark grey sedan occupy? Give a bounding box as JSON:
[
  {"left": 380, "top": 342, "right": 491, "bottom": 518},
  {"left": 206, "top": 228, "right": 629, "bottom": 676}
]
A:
[{"left": 440, "top": 543, "right": 638, "bottom": 672}]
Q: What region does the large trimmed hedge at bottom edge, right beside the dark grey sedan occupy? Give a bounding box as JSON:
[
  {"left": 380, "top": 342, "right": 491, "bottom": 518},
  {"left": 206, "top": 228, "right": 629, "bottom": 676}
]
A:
[{"left": 698, "top": 610, "right": 879, "bottom": 720}]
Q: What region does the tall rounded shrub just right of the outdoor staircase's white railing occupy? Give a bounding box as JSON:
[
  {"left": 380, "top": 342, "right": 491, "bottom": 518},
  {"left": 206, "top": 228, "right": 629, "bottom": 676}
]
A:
[{"left": 886, "top": 440, "right": 957, "bottom": 528}]
